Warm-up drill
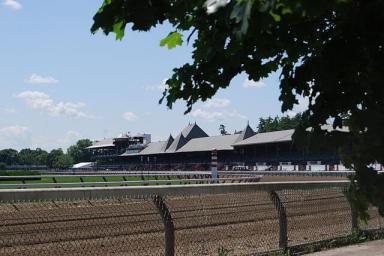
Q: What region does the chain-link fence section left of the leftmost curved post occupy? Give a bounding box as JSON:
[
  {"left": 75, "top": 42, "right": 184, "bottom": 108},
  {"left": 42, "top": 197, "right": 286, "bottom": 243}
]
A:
[{"left": 0, "top": 199, "right": 164, "bottom": 256}]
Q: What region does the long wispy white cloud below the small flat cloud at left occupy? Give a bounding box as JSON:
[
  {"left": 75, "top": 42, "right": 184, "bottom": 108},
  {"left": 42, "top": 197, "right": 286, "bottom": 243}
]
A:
[{"left": 16, "top": 91, "right": 94, "bottom": 118}]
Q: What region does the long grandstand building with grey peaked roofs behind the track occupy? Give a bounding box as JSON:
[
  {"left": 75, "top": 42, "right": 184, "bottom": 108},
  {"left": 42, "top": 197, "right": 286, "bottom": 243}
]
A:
[{"left": 89, "top": 123, "right": 340, "bottom": 170}]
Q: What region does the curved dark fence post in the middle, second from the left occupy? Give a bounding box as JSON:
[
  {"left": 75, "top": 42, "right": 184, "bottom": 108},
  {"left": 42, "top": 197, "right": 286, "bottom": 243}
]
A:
[{"left": 270, "top": 190, "right": 288, "bottom": 251}]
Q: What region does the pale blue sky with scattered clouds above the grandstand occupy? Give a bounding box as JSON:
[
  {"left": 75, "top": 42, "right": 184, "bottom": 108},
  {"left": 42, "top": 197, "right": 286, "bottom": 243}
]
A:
[{"left": 0, "top": 0, "right": 306, "bottom": 150}]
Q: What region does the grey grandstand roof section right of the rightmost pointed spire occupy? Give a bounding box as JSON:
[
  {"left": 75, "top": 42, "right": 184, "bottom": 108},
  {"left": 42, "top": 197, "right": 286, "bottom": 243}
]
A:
[{"left": 233, "top": 129, "right": 295, "bottom": 147}]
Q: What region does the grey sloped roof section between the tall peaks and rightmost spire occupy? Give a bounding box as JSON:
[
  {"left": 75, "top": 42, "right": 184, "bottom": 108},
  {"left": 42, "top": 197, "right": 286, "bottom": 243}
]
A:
[{"left": 177, "top": 134, "right": 239, "bottom": 152}]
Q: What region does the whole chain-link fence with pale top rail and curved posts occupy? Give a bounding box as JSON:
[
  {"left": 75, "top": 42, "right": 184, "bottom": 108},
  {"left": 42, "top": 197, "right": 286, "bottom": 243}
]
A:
[{"left": 0, "top": 181, "right": 384, "bottom": 255}]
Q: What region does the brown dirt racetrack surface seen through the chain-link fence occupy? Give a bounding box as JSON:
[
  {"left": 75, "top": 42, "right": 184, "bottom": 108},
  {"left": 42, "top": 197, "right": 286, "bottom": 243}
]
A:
[{"left": 0, "top": 186, "right": 383, "bottom": 256}]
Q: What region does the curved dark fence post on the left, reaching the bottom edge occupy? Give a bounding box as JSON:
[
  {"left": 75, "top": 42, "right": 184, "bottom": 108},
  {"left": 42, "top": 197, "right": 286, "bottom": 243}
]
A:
[{"left": 153, "top": 195, "right": 175, "bottom": 256}]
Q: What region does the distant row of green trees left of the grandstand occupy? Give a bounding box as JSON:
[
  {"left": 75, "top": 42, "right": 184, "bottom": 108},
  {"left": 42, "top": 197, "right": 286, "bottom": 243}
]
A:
[{"left": 0, "top": 139, "right": 92, "bottom": 169}]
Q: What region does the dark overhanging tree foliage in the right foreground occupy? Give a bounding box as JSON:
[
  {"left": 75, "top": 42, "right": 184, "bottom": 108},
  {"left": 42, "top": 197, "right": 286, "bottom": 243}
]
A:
[{"left": 91, "top": 0, "right": 384, "bottom": 218}]
